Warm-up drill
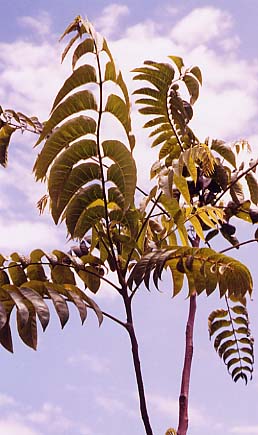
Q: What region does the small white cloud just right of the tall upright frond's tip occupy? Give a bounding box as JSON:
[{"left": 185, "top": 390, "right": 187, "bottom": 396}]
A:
[{"left": 95, "top": 3, "right": 129, "bottom": 37}]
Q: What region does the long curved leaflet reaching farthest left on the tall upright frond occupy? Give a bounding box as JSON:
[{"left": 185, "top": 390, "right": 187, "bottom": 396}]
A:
[{"left": 33, "top": 115, "right": 96, "bottom": 180}]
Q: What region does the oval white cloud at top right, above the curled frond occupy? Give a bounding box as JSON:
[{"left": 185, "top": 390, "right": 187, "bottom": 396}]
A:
[{"left": 171, "top": 6, "right": 233, "bottom": 47}]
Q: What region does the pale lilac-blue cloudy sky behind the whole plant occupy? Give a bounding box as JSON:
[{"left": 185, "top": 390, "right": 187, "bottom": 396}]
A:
[{"left": 0, "top": 0, "right": 258, "bottom": 435}]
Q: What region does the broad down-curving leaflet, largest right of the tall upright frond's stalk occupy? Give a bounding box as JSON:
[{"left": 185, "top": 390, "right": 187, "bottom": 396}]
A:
[{"left": 102, "top": 140, "right": 136, "bottom": 208}]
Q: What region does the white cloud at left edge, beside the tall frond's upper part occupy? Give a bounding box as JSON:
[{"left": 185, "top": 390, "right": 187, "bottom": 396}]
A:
[{"left": 0, "top": 40, "right": 67, "bottom": 117}]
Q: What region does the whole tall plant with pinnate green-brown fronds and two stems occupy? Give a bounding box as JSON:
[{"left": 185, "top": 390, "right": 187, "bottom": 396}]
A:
[{"left": 0, "top": 17, "right": 258, "bottom": 435}]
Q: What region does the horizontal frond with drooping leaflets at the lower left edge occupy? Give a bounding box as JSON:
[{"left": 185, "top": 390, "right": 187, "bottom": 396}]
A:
[{"left": 0, "top": 249, "right": 103, "bottom": 352}]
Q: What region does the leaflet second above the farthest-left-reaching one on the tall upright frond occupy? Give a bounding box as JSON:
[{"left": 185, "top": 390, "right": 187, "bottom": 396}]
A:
[{"left": 51, "top": 65, "right": 97, "bottom": 113}]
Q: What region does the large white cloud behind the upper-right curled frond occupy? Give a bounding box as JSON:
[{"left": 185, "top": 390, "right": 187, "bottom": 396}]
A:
[{"left": 110, "top": 12, "right": 258, "bottom": 143}]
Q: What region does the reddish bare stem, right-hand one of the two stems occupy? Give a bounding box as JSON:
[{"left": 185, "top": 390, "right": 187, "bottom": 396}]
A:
[{"left": 177, "top": 294, "right": 196, "bottom": 435}]
